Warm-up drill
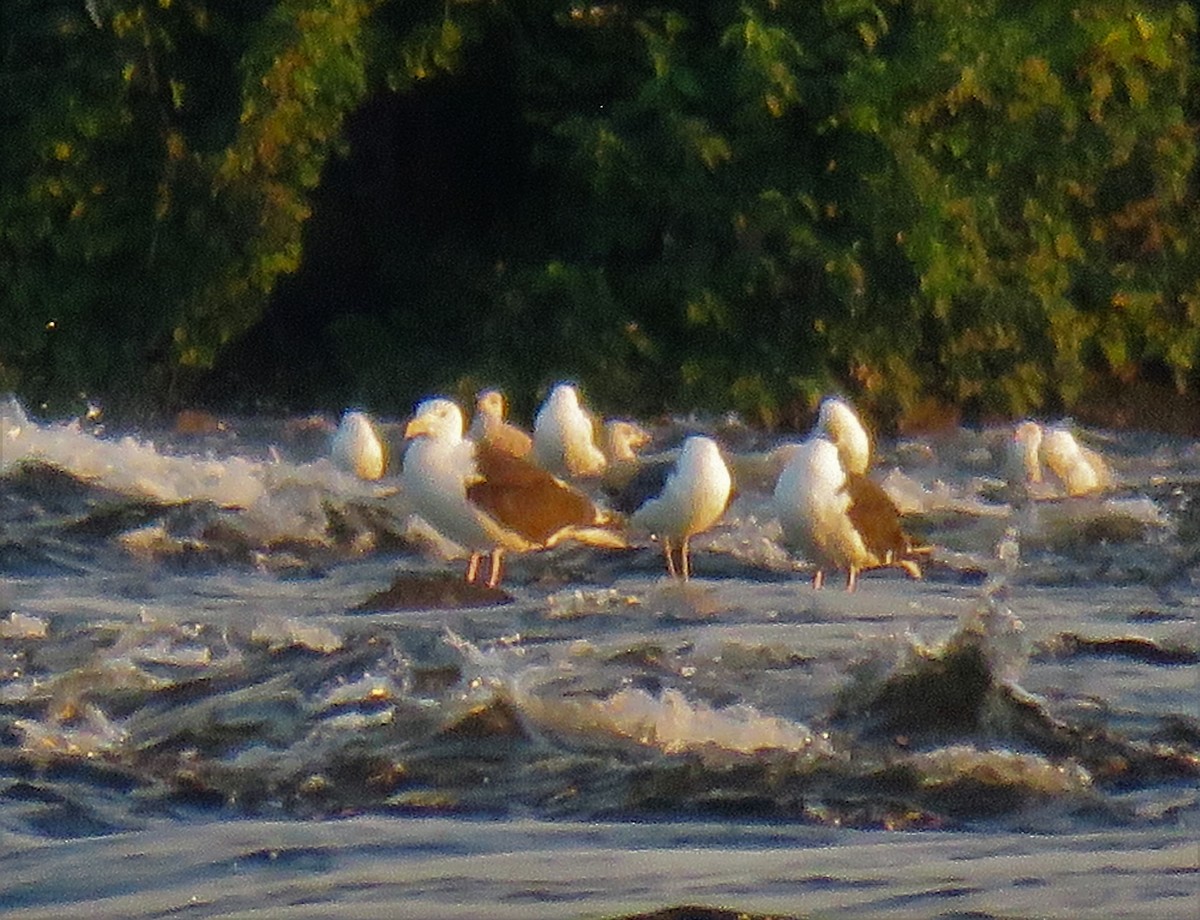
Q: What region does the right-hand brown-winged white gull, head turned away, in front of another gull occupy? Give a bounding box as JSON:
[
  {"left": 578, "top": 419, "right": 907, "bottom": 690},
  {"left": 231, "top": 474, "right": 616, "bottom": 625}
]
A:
[{"left": 774, "top": 432, "right": 928, "bottom": 591}]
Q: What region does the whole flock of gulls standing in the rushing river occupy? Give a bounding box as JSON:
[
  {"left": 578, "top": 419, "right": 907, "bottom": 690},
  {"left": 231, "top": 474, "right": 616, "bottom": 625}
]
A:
[{"left": 331, "top": 384, "right": 1110, "bottom": 590}]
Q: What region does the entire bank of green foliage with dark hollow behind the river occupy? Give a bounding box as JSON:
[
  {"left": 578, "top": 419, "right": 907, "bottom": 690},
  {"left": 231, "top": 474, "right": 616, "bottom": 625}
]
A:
[{"left": 0, "top": 0, "right": 1200, "bottom": 425}]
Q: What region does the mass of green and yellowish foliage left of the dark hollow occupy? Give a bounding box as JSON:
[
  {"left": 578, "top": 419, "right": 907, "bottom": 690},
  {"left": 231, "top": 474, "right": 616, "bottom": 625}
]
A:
[{"left": 0, "top": 0, "right": 371, "bottom": 410}]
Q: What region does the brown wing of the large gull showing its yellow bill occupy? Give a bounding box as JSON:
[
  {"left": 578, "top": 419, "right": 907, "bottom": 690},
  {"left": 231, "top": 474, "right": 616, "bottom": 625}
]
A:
[{"left": 467, "top": 444, "right": 598, "bottom": 543}]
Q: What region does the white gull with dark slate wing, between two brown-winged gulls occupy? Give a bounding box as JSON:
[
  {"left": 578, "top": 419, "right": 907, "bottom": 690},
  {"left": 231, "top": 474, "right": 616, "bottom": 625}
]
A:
[{"left": 613, "top": 435, "right": 733, "bottom": 581}]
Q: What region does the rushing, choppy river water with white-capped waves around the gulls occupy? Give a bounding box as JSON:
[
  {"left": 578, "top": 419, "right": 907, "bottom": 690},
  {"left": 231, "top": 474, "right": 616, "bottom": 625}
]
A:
[{"left": 0, "top": 401, "right": 1200, "bottom": 918}]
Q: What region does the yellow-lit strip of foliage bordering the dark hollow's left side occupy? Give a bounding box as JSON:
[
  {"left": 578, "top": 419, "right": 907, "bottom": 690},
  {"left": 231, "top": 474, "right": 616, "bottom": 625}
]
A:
[{"left": 173, "top": 0, "right": 376, "bottom": 368}]
